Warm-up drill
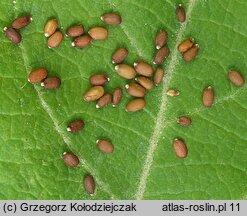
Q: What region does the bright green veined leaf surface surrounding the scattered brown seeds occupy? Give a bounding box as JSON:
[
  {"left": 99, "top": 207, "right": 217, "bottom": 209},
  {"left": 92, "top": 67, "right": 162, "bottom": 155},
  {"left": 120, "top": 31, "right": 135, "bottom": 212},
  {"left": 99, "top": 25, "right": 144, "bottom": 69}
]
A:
[{"left": 0, "top": 0, "right": 247, "bottom": 199}]
